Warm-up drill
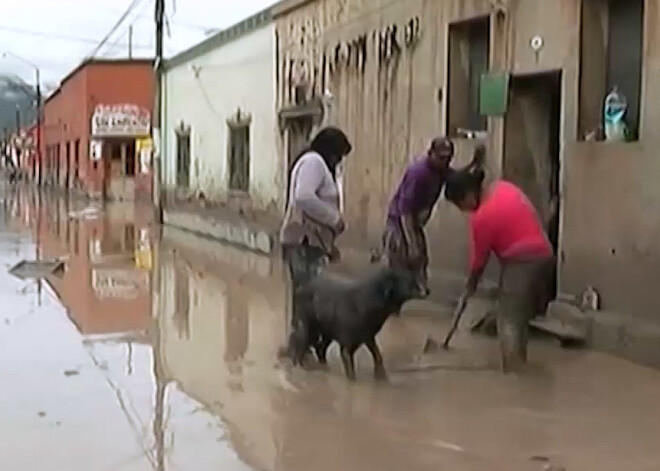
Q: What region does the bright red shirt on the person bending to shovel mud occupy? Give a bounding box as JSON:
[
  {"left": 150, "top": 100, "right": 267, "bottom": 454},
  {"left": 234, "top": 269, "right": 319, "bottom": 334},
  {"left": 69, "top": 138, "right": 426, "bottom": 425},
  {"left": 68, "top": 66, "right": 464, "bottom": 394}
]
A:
[{"left": 470, "top": 180, "right": 553, "bottom": 272}]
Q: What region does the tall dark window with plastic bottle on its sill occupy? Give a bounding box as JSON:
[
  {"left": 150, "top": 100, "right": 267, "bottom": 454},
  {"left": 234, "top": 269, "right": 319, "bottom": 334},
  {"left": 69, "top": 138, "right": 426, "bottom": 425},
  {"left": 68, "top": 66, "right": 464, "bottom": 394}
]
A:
[{"left": 578, "top": 0, "right": 644, "bottom": 140}]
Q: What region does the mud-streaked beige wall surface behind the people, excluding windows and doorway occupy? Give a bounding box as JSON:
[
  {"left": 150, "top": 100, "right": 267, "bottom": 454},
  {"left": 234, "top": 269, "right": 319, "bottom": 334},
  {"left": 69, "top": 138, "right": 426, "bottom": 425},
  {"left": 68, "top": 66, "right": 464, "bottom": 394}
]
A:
[{"left": 278, "top": 0, "right": 660, "bottom": 326}]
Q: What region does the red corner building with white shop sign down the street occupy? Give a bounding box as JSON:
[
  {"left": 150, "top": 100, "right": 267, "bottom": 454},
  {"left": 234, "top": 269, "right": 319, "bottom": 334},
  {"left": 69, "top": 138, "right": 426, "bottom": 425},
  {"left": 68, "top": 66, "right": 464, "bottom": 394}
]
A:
[{"left": 39, "top": 59, "right": 154, "bottom": 200}]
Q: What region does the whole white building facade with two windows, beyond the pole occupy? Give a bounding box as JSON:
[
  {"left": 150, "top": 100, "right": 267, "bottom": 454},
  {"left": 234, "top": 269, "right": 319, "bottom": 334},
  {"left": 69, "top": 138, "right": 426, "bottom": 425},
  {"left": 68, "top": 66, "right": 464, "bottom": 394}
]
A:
[{"left": 161, "top": 10, "right": 284, "bottom": 213}]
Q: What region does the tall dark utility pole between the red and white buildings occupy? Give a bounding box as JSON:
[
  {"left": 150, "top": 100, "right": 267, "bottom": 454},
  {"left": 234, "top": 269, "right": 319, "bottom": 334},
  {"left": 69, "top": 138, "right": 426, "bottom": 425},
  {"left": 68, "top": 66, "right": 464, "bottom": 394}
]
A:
[{"left": 152, "top": 0, "right": 165, "bottom": 224}]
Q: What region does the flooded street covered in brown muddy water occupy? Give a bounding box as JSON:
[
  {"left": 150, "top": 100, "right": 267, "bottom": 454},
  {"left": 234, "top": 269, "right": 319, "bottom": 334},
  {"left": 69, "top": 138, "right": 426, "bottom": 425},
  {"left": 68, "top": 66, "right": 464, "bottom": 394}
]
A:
[{"left": 0, "top": 184, "right": 660, "bottom": 471}]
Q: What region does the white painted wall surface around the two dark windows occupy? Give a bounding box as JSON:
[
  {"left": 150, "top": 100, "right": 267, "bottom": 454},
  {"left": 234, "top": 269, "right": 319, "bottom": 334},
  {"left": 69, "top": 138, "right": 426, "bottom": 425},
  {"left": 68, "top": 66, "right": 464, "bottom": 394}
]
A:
[{"left": 163, "top": 23, "right": 283, "bottom": 209}]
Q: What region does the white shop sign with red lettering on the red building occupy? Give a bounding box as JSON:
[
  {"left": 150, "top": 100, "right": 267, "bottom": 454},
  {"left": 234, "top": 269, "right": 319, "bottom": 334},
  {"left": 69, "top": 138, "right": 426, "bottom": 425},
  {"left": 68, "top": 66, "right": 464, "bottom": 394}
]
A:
[{"left": 92, "top": 104, "right": 151, "bottom": 137}]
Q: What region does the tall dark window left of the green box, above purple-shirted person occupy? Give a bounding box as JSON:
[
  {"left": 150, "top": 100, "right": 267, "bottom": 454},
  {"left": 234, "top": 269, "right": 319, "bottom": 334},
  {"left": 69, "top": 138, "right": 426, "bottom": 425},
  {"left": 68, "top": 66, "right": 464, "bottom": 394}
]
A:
[{"left": 447, "top": 17, "right": 490, "bottom": 136}]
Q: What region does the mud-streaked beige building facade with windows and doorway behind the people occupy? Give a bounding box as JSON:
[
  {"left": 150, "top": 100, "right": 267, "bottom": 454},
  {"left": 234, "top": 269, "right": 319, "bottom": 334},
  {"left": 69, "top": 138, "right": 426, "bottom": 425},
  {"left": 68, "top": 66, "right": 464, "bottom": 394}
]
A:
[{"left": 275, "top": 0, "right": 660, "bottom": 336}]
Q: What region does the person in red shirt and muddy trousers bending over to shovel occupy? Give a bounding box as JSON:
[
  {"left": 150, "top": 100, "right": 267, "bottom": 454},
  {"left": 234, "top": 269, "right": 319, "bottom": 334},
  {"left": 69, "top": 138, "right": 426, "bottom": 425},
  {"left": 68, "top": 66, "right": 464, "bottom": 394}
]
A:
[{"left": 445, "top": 170, "right": 554, "bottom": 371}]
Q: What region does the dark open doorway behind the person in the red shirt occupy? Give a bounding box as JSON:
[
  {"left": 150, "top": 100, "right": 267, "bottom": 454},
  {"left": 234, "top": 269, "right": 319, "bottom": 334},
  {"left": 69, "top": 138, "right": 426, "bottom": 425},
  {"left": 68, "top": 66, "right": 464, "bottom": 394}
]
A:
[{"left": 502, "top": 71, "right": 562, "bottom": 312}]
